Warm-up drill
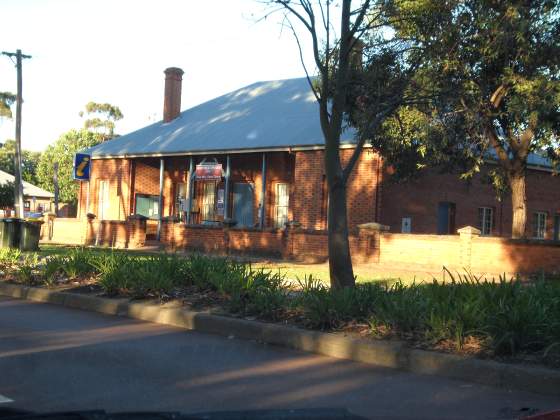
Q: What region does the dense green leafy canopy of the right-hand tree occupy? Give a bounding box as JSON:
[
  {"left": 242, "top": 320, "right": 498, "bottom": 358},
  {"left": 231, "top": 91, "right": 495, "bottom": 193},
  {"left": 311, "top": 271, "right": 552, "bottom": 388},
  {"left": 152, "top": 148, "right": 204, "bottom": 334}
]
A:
[{"left": 376, "top": 0, "right": 560, "bottom": 190}]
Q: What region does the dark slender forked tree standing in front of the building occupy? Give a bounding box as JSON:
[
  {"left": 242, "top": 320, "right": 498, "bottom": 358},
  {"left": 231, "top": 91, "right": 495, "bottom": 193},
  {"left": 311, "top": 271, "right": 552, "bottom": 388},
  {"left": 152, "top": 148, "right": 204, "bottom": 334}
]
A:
[{"left": 268, "top": 0, "right": 428, "bottom": 288}]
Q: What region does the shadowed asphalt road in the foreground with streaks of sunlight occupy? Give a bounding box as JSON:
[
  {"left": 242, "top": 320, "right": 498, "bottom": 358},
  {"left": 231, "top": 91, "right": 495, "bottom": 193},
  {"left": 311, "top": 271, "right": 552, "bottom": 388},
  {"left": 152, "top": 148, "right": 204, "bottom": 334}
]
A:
[{"left": 0, "top": 298, "right": 560, "bottom": 419}]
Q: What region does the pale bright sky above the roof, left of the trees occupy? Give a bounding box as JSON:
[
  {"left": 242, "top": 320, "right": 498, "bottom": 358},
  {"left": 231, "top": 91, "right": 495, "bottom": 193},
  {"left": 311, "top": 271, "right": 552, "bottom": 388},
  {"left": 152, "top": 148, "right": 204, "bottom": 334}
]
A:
[{"left": 0, "top": 0, "right": 313, "bottom": 151}]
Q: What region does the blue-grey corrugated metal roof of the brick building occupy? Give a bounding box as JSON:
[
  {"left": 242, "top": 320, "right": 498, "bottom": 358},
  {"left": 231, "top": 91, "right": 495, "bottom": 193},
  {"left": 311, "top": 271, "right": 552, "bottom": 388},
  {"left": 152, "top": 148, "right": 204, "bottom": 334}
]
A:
[{"left": 85, "top": 78, "right": 353, "bottom": 158}]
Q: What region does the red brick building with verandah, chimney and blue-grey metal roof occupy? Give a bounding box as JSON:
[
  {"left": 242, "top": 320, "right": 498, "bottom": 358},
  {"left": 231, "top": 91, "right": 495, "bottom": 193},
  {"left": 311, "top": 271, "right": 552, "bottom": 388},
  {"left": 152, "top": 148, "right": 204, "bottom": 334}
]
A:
[{"left": 78, "top": 68, "right": 560, "bottom": 254}]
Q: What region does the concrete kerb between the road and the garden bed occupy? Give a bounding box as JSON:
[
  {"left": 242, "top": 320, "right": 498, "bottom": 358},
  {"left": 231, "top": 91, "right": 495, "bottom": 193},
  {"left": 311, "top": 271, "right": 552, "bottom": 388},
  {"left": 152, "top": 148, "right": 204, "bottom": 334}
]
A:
[{"left": 0, "top": 282, "right": 560, "bottom": 396}]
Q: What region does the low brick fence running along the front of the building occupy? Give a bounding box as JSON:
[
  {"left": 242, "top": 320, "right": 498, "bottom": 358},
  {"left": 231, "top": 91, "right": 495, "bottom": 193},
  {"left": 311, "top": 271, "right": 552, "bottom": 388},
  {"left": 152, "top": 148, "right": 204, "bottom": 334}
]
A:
[{"left": 42, "top": 217, "right": 560, "bottom": 276}]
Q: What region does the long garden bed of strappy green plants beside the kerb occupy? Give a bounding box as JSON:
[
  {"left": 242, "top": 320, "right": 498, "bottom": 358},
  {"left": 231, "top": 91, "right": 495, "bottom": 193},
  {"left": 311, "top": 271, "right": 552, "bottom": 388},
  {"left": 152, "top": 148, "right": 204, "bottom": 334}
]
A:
[{"left": 0, "top": 249, "right": 560, "bottom": 367}]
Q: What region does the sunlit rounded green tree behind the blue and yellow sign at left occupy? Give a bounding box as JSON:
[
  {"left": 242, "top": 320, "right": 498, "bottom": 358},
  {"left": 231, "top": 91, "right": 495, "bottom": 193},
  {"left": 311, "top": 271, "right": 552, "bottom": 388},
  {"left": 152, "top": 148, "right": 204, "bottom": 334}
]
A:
[{"left": 37, "top": 129, "right": 103, "bottom": 204}]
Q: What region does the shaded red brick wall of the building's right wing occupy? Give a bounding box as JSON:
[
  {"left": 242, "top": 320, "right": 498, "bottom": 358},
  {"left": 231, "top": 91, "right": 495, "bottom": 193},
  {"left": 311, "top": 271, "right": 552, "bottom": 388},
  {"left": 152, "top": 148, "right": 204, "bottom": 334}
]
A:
[{"left": 380, "top": 170, "right": 560, "bottom": 239}]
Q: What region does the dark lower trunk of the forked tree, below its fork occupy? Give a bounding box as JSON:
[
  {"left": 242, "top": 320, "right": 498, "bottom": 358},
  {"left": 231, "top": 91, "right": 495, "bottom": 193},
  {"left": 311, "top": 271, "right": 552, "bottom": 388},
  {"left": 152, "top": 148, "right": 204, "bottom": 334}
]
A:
[{"left": 328, "top": 181, "right": 355, "bottom": 289}]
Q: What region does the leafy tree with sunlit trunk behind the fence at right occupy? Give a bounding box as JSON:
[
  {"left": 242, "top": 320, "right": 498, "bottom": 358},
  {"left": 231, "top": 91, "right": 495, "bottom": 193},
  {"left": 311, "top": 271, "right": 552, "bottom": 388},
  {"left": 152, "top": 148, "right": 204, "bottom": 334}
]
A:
[{"left": 397, "top": 0, "right": 560, "bottom": 238}]
